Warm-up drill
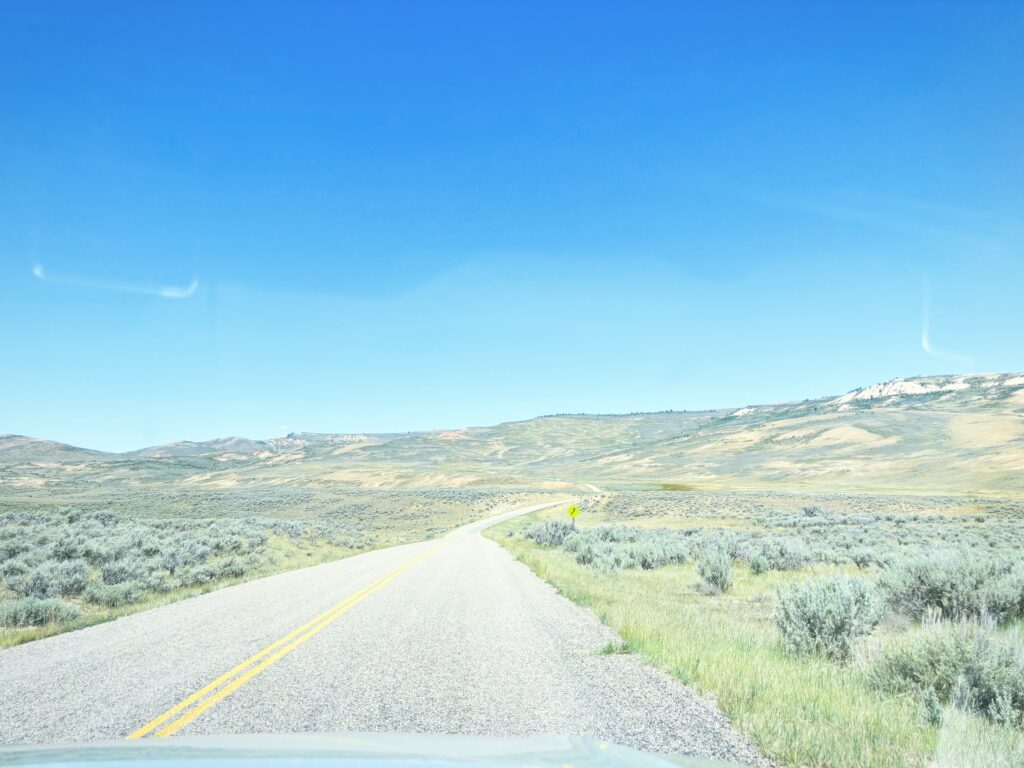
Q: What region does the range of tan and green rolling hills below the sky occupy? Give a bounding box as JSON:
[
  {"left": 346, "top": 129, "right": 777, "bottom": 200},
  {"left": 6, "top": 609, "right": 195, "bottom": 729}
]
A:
[{"left": 0, "top": 374, "right": 1024, "bottom": 496}]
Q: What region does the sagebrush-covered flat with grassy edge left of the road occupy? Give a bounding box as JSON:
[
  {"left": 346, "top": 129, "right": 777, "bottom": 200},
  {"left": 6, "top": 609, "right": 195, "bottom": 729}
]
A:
[{"left": 0, "top": 488, "right": 538, "bottom": 646}]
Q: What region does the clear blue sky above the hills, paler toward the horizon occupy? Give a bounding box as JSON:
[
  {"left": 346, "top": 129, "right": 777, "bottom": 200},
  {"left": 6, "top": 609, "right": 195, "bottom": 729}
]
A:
[{"left": 0, "top": 0, "right": 1024, "bottom": 450}]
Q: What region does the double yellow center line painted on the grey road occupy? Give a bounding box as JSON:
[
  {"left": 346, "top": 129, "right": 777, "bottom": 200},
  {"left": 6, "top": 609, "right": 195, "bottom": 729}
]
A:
[{"left": 128, "top": 544, "right": 444, "bottom": 738}]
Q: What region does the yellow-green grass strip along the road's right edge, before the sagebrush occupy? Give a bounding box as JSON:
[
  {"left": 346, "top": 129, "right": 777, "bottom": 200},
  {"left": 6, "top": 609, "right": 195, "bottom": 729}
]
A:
[{"left": 486, "top": 515, "right": 937, "bottom": 768}]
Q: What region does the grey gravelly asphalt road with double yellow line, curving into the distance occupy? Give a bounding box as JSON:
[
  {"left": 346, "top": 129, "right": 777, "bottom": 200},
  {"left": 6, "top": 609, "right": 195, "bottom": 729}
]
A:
[{"left": 0, "top": 505, "right": 761, "bottom": 764}]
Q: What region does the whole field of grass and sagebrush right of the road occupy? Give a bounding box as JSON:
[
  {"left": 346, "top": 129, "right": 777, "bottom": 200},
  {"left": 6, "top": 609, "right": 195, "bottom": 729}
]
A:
[{"left": 490, "top": 490, "right": 1024, "bottom": 767}]
